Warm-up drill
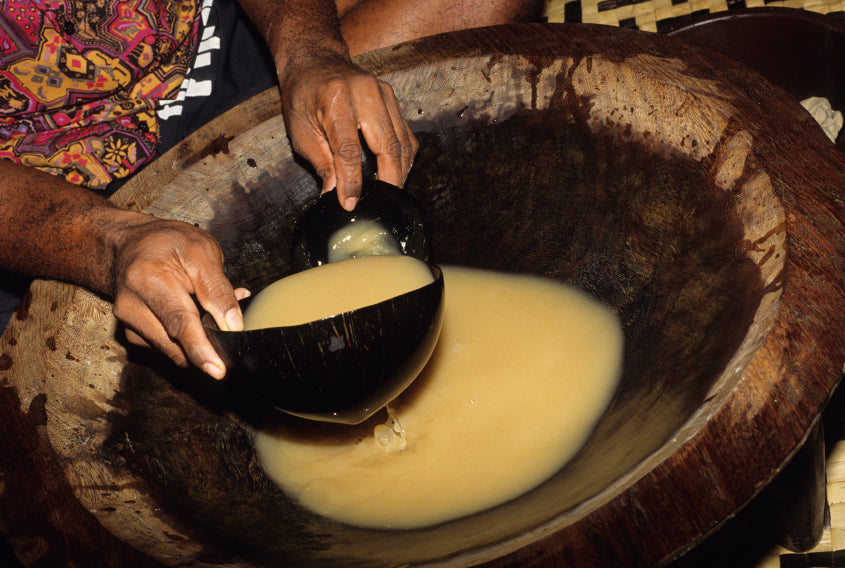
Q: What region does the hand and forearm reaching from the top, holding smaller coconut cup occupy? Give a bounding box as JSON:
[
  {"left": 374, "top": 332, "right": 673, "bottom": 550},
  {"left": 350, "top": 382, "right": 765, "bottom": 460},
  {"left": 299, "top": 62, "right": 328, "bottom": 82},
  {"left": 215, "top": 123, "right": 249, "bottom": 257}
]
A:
[{"left": 234, "top": 0, "right": 419, "bottom": 210}]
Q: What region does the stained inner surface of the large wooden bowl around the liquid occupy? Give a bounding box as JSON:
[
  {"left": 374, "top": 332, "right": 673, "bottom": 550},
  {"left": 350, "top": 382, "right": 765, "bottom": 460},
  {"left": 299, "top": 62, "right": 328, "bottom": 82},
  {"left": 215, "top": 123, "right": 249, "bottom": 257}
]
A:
[{"left": 95, "top": 28, "right": 786, "bottom": 566}]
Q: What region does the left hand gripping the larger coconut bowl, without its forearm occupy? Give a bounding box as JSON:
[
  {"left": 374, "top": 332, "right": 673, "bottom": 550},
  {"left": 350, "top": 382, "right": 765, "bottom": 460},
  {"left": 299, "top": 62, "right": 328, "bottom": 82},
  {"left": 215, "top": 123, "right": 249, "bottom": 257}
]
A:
[{"left": 113, "top": 218, "right": 249, "bottom": 379}]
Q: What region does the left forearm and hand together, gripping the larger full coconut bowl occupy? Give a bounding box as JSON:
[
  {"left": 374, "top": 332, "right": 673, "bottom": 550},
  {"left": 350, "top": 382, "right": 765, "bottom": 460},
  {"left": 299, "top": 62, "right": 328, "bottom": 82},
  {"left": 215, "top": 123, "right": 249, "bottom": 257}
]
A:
[{"left": 0, "top": 160, "right": 247, "bottom": 378}]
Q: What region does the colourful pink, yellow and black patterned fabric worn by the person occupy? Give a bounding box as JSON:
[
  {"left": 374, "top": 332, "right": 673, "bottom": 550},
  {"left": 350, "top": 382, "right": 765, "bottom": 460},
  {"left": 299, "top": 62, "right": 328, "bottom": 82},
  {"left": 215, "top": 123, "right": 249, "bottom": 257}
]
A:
[{"left": 0, "top": 0, "right": 201, "bottom": 189}]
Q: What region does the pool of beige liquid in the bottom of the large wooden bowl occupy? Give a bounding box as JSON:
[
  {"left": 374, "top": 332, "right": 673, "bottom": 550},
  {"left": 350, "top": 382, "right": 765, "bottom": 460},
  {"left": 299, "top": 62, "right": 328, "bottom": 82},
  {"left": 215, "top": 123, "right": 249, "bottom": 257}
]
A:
[{"left": 255, "top": 266, "right": 623, "bottom": 529}]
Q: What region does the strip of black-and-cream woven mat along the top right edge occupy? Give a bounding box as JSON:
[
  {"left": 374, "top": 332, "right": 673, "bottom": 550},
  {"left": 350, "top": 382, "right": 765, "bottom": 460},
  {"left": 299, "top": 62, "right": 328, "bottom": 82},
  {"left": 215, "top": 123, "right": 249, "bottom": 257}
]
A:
[{"left": 545, "top": 0, "right": 845, "bottom": 32}]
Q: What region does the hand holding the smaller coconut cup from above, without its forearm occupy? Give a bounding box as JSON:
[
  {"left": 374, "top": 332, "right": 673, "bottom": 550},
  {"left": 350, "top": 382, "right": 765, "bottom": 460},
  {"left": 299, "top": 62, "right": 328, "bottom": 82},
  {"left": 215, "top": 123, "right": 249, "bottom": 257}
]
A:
[{"left": 281, "top": 56, "right": 419, "bottom": 210}]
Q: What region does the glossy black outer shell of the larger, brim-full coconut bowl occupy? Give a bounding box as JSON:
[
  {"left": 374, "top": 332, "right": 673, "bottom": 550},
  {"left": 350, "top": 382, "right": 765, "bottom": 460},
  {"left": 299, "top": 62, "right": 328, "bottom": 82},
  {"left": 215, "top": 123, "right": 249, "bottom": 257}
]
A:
[{"left": 203, "top": 235, "right": 443, "bottom": 424}]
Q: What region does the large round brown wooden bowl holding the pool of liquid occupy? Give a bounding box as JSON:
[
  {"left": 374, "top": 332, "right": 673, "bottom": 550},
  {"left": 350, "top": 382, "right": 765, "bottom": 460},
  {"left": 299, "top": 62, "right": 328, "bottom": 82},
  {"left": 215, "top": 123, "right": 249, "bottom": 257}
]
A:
[{"left": 0, "top": 25, "right": 845, "bottom": 567}]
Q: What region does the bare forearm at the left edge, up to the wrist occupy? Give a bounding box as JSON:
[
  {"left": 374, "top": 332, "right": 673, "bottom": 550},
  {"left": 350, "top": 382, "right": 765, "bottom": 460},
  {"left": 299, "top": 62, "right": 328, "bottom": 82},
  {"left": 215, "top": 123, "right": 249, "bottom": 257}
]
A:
[{"left": 0, "top": 159, "right": 147, "bottom": 295}]
